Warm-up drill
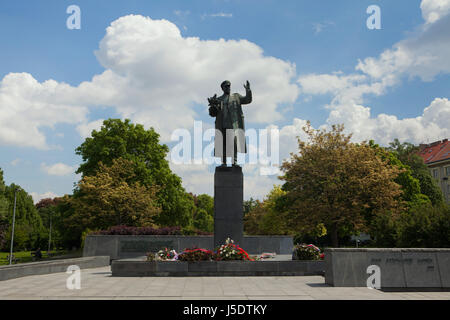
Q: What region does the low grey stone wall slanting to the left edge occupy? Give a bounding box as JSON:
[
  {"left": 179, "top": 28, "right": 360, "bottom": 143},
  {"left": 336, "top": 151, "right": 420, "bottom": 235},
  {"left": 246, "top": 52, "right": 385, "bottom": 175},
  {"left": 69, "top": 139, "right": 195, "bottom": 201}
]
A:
[{"left": 0, "top": 256, "right": 110, "bottom": 281}]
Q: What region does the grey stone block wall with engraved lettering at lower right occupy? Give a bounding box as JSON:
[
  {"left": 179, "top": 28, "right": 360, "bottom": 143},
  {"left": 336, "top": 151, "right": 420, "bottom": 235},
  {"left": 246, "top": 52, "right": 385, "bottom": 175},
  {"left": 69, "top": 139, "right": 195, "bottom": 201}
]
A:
[{"left": 325, "top": 248, "right": 450, "bottom": 289}]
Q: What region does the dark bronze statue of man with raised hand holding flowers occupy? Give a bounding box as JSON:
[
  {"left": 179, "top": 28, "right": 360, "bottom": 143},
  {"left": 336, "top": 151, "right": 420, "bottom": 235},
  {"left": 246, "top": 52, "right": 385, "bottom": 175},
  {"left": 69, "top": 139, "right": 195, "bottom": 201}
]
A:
[{"left": 208, "top": 80, "right": 252, "bottom": 166}]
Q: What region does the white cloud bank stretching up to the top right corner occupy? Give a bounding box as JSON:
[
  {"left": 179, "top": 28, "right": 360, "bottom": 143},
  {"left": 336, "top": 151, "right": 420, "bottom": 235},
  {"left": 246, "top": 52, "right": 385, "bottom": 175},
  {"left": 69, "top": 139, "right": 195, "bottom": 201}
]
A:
[{"left": 298, "top": 0, "right": 450, "bottom": 145}]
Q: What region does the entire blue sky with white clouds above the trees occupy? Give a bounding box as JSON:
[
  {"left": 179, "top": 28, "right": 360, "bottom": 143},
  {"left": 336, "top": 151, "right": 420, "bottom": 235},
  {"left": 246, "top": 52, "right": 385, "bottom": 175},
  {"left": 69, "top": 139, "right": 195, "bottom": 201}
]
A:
[{"left": 0, "top": 0, "right": 450, "bottom": 199}]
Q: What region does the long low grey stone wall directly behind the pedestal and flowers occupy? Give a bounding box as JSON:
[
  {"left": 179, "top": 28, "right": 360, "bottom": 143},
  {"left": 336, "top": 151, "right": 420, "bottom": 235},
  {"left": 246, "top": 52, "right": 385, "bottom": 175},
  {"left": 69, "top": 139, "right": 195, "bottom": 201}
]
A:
[{"left": 83, "top": 235, "right": 293, "bottom": 260}]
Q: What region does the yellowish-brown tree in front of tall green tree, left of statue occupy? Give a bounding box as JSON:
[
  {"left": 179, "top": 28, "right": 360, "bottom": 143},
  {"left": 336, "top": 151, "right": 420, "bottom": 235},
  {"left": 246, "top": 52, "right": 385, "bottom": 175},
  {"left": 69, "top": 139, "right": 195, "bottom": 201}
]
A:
[{"left": 70, "top": 158, "right": 161, "bottom": 230}]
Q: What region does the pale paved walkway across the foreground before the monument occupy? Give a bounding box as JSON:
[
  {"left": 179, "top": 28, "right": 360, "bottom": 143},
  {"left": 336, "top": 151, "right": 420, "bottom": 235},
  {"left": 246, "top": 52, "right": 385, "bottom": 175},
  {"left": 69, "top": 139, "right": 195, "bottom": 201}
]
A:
[{"left": 0, "top": 267, "right": 450, "bottom": 300}]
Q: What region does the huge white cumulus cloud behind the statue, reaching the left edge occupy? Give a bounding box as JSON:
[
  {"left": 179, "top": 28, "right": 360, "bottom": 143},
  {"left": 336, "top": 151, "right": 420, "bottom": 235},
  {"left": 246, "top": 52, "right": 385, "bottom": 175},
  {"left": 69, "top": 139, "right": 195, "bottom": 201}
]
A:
[{"left": 0, "top": 15, "right": 298, "bottom": 149}]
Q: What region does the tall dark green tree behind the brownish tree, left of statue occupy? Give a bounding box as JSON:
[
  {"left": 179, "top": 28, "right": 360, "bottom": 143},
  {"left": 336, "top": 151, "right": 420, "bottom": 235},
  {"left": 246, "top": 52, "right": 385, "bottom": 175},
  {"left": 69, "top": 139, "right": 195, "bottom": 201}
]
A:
[{"left": 75, "top": 119, "right": 194, "bottom": 226}]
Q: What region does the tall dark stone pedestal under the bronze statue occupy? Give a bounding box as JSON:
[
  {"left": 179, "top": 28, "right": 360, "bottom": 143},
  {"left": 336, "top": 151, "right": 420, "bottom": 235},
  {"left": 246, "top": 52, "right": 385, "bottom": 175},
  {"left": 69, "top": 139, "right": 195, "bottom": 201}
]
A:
[{"left": 214, "top": 166, "right": 244, "bottom": 247}]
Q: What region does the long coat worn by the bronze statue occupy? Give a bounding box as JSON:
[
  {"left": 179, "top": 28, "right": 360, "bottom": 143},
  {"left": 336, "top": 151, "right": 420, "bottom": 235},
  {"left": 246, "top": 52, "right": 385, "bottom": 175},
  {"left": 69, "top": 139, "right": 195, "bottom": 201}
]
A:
[{"left": 214, "top": 90, "right": 252, "bottom": 157}]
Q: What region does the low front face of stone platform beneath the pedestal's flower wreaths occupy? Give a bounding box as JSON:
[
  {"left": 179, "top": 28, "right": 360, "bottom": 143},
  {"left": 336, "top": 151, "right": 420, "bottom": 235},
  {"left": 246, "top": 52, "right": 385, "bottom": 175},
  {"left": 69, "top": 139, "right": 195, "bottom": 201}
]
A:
[{"left": 111, "top": 259, "right": 324, "bottom": 277}]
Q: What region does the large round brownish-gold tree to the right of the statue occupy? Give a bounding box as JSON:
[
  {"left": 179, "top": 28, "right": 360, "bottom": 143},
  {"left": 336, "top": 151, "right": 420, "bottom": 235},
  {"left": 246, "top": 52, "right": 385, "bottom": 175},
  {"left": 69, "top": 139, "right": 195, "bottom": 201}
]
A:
[{"left": 280, "top": 122, "right": 403, "bottom": 247}]
